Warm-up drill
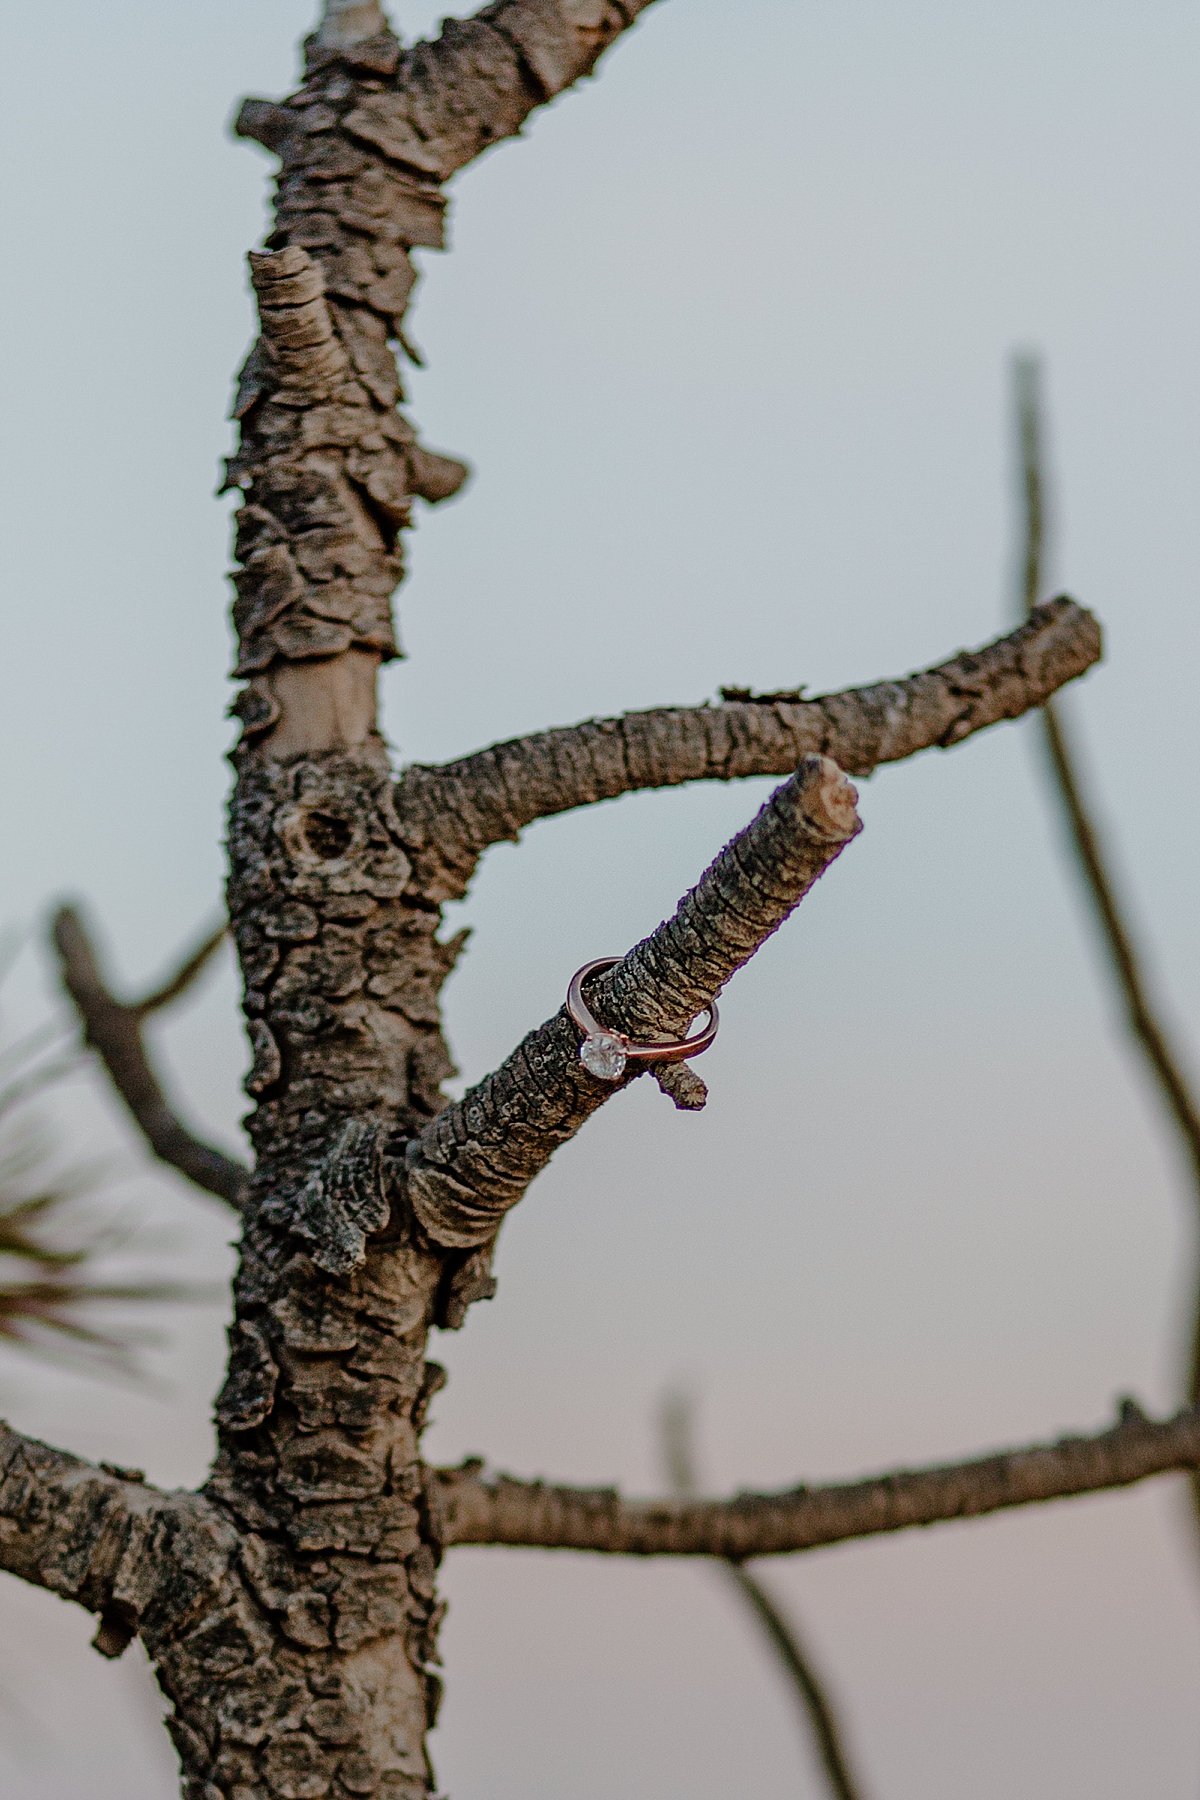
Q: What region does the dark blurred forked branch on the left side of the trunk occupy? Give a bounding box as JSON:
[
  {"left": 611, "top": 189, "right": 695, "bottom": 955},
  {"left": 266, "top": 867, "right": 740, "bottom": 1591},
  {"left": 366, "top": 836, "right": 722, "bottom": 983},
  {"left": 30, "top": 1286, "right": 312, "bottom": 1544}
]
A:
[{"left": 52, "top": 907, "right": 246, "bottom": 1208}]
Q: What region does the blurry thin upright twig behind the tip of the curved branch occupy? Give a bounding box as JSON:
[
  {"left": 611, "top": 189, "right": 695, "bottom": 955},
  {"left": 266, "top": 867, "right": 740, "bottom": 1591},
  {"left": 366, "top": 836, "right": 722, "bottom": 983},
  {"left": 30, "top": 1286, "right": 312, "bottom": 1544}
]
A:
[{"left": 1013, "top": 356, "right": 1200, "bottom": 1525}]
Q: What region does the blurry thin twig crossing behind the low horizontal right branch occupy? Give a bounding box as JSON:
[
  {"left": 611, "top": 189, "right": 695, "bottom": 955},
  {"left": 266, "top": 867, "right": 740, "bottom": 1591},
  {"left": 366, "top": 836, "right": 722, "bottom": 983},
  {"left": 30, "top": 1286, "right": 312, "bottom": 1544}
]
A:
[{"left": 662, "top": 1393, "right": 864, "bottom": 1800}]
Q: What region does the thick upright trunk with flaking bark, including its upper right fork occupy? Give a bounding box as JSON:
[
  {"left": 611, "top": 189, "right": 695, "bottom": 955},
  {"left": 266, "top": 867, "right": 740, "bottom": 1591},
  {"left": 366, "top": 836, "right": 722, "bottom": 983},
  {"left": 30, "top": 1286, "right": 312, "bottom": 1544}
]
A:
[{"left": 158, "top": 10, "right": 665, "bottom": 1800}]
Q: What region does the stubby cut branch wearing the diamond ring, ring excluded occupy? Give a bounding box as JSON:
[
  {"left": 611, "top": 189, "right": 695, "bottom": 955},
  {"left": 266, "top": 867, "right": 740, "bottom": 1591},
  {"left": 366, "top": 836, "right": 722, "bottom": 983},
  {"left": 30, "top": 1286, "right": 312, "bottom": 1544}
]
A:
[{"left": 385, "top": 756, "right": 860, "bottom": 1255}]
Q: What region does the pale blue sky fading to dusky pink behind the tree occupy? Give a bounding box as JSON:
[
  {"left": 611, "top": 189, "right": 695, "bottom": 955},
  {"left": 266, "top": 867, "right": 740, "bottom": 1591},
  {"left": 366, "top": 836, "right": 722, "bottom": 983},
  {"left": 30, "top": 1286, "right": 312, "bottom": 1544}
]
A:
[{"left": 0, "top": 0, "right": 1200, "bottom": 1800}]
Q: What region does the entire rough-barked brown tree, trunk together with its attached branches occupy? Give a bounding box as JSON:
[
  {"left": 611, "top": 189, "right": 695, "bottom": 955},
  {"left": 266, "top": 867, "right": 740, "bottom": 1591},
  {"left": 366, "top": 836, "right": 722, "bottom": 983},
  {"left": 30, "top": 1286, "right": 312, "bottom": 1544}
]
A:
[{"left": 0, "top": 0, "right": 1180, "bottom": 1800}]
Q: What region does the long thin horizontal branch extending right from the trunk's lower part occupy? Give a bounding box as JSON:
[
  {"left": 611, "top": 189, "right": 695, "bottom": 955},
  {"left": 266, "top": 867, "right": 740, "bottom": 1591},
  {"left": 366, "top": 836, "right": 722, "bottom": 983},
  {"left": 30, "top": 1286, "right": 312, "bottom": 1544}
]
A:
[{"left": 437, "top": 1400, "right": 1200, "bottom": 1562}]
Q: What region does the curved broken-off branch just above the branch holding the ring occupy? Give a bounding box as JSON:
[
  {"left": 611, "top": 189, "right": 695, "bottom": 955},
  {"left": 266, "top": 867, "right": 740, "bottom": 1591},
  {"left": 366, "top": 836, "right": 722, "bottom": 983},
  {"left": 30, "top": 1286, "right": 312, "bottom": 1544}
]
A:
[{"left": 396, "top": 599, "right": 1101, "bottom": 898}]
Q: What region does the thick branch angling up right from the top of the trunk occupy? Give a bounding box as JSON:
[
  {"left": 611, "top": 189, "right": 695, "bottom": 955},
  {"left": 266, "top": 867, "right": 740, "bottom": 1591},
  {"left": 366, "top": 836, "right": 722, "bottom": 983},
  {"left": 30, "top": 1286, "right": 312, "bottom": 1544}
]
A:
[{"left": 338, "top": 0, "right": 651, "bottom": 182}]
